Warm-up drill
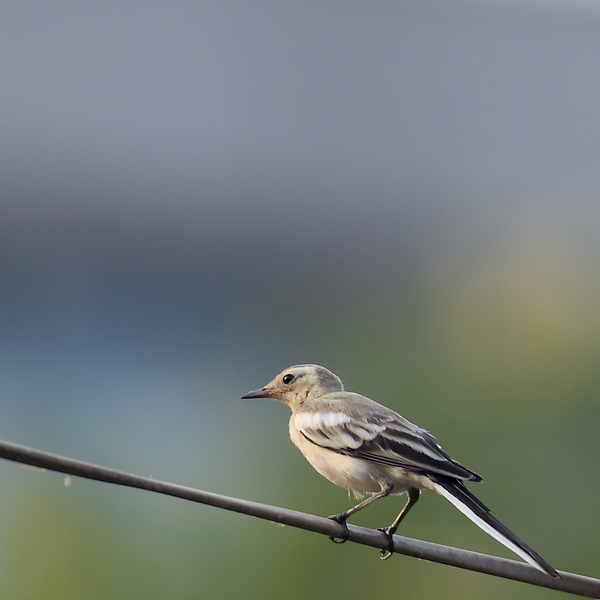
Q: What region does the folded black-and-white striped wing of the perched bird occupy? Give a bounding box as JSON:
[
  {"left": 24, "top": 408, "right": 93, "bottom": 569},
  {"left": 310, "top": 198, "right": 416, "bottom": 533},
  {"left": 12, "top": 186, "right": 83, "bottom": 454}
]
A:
[{"left": 294, "top": 398, "right": 481, "bottom": 481}]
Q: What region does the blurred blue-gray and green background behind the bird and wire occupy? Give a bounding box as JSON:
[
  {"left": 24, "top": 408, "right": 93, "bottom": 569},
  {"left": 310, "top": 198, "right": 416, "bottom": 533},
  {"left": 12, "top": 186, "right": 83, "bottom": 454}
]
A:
[{"left": 0, "top": 0, "right": 600, "bottom": 600}]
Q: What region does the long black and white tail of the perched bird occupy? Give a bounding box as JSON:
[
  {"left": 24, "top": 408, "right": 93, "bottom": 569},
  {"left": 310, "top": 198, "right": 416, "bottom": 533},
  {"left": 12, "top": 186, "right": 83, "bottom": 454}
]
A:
[{"left": 430, "top": 475, "right": 560, "bottom": 578}]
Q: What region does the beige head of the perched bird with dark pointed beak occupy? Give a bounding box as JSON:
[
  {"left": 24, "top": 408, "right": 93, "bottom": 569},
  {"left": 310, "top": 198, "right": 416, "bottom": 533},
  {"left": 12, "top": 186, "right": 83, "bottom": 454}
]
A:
[{"left": 242, "top": 365, "right": 344, "bottom": 410}]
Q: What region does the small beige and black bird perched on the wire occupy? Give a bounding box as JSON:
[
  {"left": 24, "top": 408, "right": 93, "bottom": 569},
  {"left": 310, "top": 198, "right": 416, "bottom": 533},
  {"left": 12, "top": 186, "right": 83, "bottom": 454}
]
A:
[{"left": 242, "top": 364, "right": 560, "bottom": 578}]
